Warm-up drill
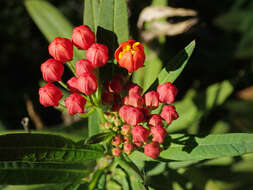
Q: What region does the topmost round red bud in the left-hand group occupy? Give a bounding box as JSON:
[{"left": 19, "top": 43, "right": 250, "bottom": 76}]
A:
[{"left": 72, "top": 25, "right": 95, "bottom": 50}]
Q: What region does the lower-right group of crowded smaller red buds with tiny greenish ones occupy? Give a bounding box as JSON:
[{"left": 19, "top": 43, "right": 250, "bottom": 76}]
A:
[{"left": 102, "top": 80, "right": 178, "bottom": 158}]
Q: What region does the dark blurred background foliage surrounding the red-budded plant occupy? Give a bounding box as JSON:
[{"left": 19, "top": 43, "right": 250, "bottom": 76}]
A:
[{"left": 0, "top": 0, "right": 253, "bottom": 190}]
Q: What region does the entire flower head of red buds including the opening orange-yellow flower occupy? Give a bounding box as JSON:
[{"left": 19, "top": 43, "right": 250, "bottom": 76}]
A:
[{"left": 39, "top": 25, "right": 178, "bottom": 158}]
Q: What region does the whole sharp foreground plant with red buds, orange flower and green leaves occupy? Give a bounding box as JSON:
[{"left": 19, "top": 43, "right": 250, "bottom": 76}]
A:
[{"left": 0, "top": 0, "right": 253, "bottom": 190}]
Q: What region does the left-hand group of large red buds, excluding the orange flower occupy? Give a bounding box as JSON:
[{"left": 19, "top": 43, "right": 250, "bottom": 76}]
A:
[{"left": 39, "top": 25, "right": 108, "bottom": 115}]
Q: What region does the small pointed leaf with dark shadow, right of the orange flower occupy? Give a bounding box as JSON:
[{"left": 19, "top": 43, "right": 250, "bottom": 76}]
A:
[{"left": 158, "top": 41, "right": 195, "bottom": 84}]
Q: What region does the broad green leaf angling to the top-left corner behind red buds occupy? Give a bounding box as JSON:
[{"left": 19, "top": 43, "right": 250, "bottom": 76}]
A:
[{"left": 25, "top": 0, "right": 73, "bottom": 42}]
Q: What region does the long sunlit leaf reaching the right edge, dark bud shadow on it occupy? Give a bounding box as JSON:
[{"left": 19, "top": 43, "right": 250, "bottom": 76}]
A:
[{"left": 130, "top": 133, "right": 253, "bottom": 161}]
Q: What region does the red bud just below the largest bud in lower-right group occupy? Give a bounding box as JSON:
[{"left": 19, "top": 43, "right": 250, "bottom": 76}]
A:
[{"left": 132, "top": 125, "right": 149, "bottom": 143}]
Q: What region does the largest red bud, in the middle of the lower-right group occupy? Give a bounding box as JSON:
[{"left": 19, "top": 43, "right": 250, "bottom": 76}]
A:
[{"left": 119, "top": 105, "right": 144, "bottom": 125}]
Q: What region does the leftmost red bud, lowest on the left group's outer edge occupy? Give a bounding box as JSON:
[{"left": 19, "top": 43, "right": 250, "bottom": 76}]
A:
[{"left": 39, "top": 83, "right": 62, "bottom": 107}]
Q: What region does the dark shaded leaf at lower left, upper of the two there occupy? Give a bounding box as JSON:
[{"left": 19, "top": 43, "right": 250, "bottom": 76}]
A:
[{"left": 0, "top": 133, "right": 104, "bottom": 162}]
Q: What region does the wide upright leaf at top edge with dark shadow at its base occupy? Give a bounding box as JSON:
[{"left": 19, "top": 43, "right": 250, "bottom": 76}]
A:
[{"left": 97, "top": 0, "right": 129, "bottom": 58}]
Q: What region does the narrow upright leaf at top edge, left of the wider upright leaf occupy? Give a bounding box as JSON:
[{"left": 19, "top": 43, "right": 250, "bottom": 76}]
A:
[{"left": 83, "top": 0, "right": 100, "bottom": 34}]
